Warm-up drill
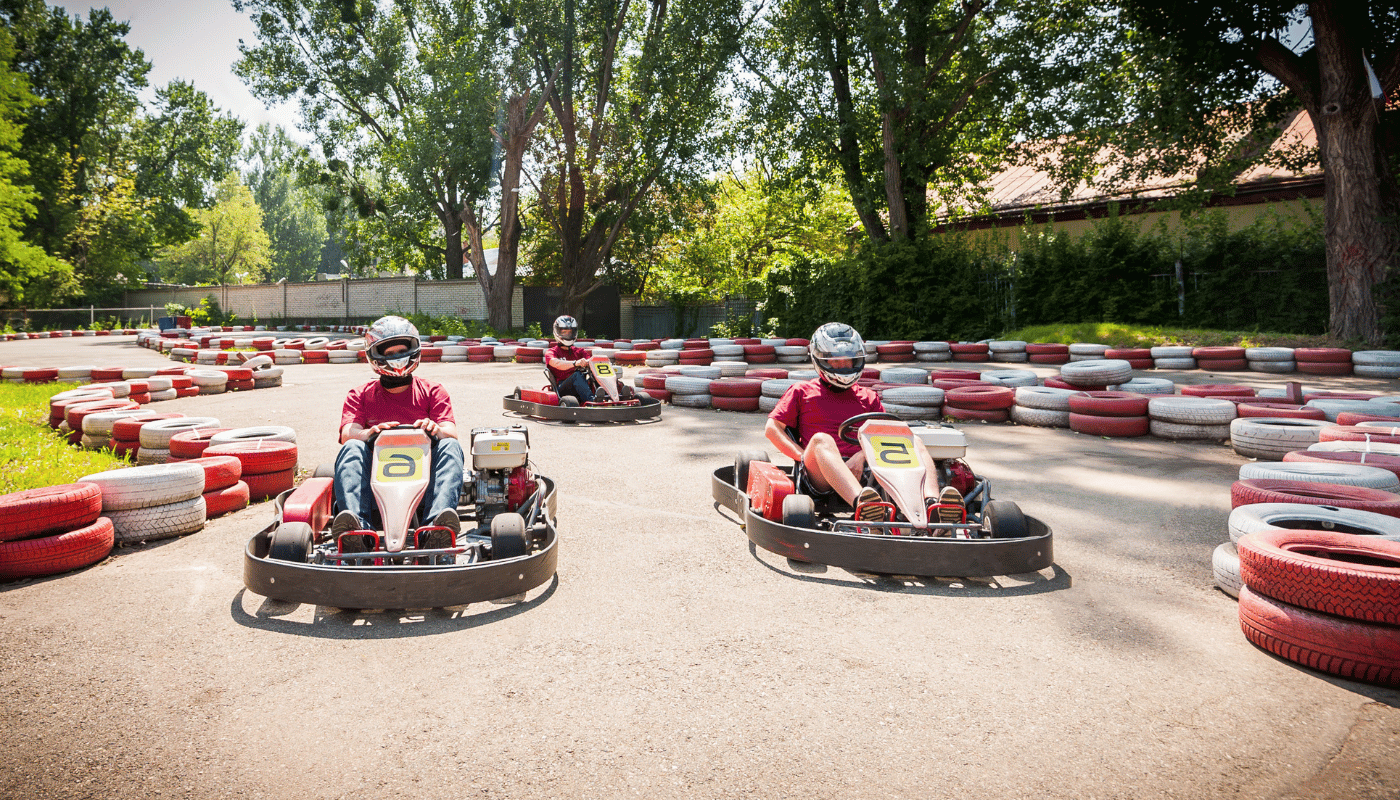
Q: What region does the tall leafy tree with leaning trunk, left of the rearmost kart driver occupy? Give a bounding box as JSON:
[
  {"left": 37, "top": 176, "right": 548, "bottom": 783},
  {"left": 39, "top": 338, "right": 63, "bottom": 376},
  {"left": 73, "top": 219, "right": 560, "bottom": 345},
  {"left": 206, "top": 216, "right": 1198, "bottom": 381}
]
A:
[{"left": 235, "top": 0, "right": 514, "bottom": 328}]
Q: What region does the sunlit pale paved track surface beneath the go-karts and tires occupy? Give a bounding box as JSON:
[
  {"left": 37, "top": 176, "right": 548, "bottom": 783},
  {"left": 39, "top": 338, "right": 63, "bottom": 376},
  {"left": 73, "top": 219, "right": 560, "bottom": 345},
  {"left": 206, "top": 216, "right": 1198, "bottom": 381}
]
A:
[{"left": 0, "top": 338, "right": 1400, "bottom": 800}]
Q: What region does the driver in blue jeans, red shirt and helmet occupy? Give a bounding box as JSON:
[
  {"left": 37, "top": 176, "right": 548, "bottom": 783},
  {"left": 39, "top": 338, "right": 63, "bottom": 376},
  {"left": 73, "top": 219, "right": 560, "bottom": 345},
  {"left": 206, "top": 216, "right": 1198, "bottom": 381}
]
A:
[{"left": 332, "top": 317, "right": 463, "bottom": 549}]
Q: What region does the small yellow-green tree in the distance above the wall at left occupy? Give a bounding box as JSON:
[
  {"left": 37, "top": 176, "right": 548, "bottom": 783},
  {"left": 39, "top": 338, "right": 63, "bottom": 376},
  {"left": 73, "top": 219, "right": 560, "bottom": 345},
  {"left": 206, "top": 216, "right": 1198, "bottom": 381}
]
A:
[{"left": 160, "top": 174, "right": 269, "bottom": 286}]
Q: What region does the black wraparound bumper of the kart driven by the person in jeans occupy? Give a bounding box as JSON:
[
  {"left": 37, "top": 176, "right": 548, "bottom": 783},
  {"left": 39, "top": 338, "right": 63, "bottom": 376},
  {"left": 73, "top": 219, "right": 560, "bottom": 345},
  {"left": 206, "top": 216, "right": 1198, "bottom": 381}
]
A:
[{"left": 244, "top": 476, "right": 559, "bottom": 608}]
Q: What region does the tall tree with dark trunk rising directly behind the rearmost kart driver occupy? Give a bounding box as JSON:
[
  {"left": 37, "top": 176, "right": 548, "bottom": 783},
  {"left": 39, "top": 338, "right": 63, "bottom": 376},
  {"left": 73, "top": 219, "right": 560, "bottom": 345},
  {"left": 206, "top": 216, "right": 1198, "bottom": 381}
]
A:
[{"left": 519, "top": 0, "right": 743, "bottom": 312}]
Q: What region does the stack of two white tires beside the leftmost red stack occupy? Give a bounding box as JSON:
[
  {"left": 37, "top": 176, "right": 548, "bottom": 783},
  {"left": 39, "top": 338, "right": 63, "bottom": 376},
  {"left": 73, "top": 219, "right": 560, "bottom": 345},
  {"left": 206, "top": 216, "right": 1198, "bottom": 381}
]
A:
[{"left": 80, "top": 464, "right": 204, "bottom": 545}]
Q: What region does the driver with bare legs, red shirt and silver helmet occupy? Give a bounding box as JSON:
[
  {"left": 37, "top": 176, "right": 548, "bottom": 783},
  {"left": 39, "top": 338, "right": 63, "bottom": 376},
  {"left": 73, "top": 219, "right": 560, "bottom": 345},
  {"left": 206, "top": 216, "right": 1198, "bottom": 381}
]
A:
[{"left": 764, "top": 322, "right": 963, "bottom": 523}]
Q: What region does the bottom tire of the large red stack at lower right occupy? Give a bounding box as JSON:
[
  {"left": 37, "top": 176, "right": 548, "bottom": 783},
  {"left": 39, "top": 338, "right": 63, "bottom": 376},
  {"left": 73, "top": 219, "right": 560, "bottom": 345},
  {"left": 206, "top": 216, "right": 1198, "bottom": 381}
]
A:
[{"left": 1239, "top": 586, "right": 1400, "bottom": 687}]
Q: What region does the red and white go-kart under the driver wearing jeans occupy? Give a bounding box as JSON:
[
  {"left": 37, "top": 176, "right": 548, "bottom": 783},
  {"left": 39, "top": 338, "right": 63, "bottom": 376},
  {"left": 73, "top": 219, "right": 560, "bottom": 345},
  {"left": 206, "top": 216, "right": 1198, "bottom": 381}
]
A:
[{"left": 244, "top": 425, "right": 559, "bottom": 608}]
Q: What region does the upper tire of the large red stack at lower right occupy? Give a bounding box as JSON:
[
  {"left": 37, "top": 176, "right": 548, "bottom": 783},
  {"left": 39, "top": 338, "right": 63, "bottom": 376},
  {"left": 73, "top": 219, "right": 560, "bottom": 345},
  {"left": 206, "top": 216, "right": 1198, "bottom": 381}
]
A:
[{"left": 1238, "top": 530, "right": 1400, "bottom": 625}]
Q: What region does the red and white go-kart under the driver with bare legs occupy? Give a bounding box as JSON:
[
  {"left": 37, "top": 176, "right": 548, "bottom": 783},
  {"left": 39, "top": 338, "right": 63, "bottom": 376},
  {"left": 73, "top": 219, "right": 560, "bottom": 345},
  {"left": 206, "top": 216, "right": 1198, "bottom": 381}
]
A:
[{"left": 710, "top": 412, "right": 1054, "bottom": 577}]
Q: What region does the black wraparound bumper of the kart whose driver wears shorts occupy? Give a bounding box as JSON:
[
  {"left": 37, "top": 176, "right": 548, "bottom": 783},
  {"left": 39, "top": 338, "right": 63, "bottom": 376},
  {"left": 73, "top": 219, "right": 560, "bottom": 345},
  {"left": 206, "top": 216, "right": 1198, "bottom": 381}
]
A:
[{"left": 710, "top": 467, "right": 1054, "bottom": 577}]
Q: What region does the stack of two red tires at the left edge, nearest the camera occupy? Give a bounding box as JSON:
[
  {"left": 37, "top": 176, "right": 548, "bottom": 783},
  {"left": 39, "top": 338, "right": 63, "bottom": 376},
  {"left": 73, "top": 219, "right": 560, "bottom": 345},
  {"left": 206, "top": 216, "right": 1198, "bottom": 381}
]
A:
[{"left": 0, "top": 483, "right": 113, "bottom": 580}]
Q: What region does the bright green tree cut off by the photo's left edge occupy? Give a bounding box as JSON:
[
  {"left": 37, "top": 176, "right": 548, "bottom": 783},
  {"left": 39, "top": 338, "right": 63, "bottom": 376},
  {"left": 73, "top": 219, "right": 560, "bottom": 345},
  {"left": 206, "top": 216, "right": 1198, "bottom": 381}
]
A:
[{"left": 0, "top": 29, "right": 73, "bottom": 305}]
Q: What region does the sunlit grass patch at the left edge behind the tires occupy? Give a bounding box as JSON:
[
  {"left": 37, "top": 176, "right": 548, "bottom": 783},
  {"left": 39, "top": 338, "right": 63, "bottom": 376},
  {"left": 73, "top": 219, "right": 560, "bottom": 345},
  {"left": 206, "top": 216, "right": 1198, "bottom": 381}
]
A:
[{"left": 0, "top": 382, "right": 127, "bottom": 495}]
